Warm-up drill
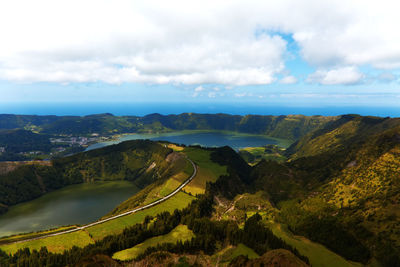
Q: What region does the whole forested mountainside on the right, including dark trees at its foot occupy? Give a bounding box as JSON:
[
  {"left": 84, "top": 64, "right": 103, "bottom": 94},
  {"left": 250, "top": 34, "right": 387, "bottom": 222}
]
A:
[{"left": 211, "top": 115, "right": 400, "bottom": 266}]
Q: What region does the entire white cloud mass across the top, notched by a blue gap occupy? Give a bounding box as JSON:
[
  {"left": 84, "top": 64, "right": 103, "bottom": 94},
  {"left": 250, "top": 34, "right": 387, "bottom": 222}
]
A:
[{"left": 0, "top": 0, "right": 400, "bottom": 86}]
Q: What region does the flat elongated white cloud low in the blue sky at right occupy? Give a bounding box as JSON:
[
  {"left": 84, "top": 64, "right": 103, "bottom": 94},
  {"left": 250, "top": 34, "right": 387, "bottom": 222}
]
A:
[{"left": 307, "top": 67, "right": 365, "bottom": 85}]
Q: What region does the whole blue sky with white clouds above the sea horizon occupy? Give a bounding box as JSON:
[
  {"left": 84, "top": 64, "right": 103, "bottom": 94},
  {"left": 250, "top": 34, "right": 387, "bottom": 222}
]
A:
[{"left": 0, "top": 0, "right": 400, "bottom": 116}]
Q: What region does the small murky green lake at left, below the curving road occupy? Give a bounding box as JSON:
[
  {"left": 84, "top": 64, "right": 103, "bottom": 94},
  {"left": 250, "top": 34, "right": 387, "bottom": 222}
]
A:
[{"left": 0, "top": 181, "right": 139, "bottom": 237}]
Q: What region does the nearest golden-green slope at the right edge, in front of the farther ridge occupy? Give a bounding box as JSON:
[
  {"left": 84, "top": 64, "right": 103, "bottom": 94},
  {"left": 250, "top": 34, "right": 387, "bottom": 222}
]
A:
[{"left": 283, "top": 126, "right": 400, "bottom": 266}]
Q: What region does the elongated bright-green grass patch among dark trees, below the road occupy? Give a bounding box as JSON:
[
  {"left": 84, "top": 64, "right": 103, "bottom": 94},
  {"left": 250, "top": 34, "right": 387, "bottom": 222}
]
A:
[{"left": 113, "top": 225, "right": 194, "bottom": 261}]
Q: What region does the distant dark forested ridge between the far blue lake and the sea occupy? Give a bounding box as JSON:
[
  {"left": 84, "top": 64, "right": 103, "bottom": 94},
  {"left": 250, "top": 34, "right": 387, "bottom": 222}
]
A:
[{"left": 0, "top": 113, "right": 337, "bottom": 140}]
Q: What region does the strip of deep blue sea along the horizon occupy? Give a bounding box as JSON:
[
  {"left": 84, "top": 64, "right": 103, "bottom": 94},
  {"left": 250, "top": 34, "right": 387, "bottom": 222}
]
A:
[{"left": 0, "top": 103, "right": 400, "bottom": 117}]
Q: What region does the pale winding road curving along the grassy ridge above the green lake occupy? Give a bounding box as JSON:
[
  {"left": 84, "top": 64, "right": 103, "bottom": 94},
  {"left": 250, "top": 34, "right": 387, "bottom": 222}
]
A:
[{"left": 7, "top": 158, "right": 197, "bottom": 244}]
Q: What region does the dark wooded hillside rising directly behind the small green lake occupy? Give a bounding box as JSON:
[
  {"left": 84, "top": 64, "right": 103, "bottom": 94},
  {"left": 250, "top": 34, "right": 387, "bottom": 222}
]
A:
[{"left": 0, "top": 140, "right": 178, "bottom": 216}]
